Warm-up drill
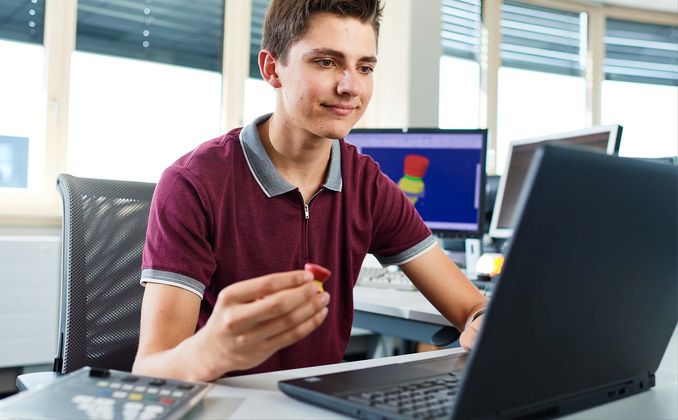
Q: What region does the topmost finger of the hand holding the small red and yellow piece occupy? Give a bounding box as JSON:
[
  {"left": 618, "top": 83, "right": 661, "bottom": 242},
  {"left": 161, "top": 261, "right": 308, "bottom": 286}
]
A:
[{"left": 219, "top": 270, "right": 313, "bottom": 303}]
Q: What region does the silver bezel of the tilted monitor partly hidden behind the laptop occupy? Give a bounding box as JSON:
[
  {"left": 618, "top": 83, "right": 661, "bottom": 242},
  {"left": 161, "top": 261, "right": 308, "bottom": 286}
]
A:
[{"left": 488, "top": 124, "right": 623, "bottom": 239}]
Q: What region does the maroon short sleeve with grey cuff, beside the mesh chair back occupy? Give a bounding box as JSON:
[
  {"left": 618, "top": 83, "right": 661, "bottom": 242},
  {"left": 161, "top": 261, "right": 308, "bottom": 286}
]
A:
[{"left": 141, "top": 167, "right": 216, "bottom": 298}]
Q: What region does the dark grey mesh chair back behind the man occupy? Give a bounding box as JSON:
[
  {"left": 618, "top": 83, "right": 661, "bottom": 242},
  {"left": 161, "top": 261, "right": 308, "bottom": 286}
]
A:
[{"left": 54, "top": 174, "right": 155, "bottom": 373}]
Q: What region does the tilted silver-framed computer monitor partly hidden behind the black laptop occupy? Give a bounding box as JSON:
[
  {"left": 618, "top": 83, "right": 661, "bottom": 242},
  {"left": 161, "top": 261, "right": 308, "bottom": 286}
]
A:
[{"left": 489, "top": 125, "right": 622, "bottom": 238}]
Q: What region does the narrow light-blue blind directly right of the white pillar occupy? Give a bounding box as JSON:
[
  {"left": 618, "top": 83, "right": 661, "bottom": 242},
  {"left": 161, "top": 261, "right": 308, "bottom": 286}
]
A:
[{"left": 440, "top": 0, "right": 482, "bottom": 61}]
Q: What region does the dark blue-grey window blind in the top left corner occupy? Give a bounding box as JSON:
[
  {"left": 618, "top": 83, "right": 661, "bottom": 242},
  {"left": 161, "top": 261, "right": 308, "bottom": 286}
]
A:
[{"left": 0, "top": 0, "right": 45, "bottom": 44}]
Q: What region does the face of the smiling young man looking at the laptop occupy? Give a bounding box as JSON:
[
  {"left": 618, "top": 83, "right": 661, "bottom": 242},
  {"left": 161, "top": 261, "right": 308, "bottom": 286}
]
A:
[{"left": 276, "top": 13, "right": 377, "bottom": 139}]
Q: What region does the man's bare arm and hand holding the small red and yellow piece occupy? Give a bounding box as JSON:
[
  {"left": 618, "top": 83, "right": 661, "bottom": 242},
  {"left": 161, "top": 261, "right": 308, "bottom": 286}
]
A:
[{"left": 132, "top": 271, "right": 329, "bottom": 381}]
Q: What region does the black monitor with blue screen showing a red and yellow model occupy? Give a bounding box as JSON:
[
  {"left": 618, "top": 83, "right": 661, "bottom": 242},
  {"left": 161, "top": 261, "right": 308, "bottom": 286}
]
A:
[{"left": 346, "top": 128, "right": 487, "bottom": 238}]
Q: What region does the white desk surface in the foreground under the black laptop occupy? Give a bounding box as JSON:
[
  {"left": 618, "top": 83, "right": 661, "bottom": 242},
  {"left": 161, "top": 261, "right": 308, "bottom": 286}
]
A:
[{"left": 190, "top": 331, "right": 678, "bottom": 419}]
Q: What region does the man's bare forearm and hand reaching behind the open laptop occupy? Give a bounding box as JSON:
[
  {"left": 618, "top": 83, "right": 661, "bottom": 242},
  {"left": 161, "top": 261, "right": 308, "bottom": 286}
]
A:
[{"left": 400, "top": 245, "right": 487, "bottom": 349}]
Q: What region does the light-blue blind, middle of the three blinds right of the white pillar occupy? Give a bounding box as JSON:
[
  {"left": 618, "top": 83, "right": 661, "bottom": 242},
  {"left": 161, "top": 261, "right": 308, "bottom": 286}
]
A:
[{"left": 500, "top": 1, "right": 586, "bottom": 76}]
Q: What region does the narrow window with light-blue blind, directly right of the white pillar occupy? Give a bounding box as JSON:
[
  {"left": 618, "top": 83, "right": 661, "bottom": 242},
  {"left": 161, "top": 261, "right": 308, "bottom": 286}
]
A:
[{"left": 438, "top": 0, "right": 481, "bottom": 128}]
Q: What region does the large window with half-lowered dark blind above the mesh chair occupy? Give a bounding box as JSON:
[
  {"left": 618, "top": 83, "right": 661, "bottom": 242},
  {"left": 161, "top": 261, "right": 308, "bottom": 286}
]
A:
[{"left": 68, "top": 0, "right": 224, "bottom": 182}]
